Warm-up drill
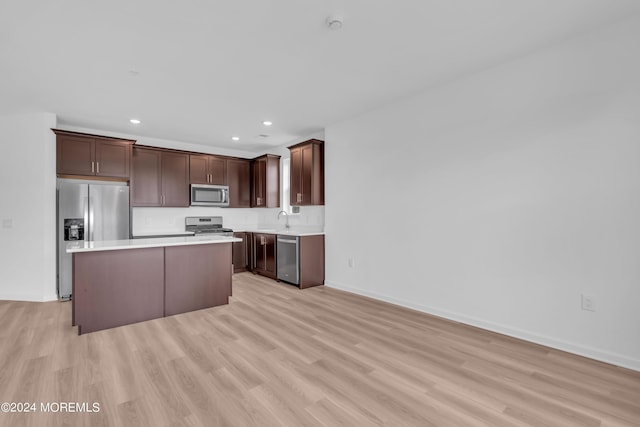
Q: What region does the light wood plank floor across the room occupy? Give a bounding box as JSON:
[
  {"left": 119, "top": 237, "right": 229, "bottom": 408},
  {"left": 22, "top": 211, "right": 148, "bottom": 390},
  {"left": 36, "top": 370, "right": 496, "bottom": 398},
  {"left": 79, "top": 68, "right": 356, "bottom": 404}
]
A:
[{"left": 0, "top": 273, "right": 640, "bottom": 427}]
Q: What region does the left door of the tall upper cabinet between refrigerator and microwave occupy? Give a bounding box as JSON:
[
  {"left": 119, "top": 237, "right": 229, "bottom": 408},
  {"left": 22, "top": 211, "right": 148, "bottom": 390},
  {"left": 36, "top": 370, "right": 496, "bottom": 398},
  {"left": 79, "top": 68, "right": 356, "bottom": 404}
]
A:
[{"left": 131, "top": 148, "right": 162, "bottom": 206}]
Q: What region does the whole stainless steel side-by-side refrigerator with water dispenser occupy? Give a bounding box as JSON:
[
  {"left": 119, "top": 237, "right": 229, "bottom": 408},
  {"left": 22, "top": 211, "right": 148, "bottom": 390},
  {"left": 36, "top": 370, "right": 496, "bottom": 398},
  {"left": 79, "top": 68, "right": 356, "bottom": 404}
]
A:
[{"left": 57, "top": 179, "right": 130, "bottom": 300}]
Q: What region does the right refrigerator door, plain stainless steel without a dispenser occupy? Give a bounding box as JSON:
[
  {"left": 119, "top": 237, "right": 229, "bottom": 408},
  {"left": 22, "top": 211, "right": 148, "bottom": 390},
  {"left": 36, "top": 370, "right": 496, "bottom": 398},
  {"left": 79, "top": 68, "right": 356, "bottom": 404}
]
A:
[{"left": 88, "top": 184, "right": 129, "bottom": 241}]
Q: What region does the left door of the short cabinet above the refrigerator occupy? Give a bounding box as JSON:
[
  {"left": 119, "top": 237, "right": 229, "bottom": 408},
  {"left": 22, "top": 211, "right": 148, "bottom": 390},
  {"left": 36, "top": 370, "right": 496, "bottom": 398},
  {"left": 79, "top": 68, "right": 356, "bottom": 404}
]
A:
[{"left": 56, "top": 135, "right": 95, "bottom": 175}]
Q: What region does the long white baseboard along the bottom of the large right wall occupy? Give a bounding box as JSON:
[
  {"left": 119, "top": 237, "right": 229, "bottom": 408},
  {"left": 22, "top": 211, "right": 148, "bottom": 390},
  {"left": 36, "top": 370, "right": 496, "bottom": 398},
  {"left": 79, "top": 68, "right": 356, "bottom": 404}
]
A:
[{"left": 325, "top": 281, "right": 640, "bottom": 371}]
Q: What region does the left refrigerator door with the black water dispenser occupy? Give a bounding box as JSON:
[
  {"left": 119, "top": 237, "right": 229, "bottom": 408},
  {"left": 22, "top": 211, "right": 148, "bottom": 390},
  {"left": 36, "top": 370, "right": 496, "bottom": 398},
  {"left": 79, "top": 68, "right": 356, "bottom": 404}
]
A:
[{"left": 57, "top": 181, "right": 89, "bottom": 299}]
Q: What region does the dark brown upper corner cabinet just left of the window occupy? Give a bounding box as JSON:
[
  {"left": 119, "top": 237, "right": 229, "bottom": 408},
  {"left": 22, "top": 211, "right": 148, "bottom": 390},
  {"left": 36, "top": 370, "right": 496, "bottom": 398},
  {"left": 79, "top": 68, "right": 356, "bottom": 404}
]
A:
[{"left": 251, "top": 154, "right": 280, "bottom": 208}]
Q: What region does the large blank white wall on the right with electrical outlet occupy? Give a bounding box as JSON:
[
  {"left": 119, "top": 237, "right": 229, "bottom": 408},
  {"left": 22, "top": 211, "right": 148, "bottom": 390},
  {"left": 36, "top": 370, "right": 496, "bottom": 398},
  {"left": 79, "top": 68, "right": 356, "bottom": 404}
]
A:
[{"left": 325, "top": 17, "right": 640, "bottom": 370}]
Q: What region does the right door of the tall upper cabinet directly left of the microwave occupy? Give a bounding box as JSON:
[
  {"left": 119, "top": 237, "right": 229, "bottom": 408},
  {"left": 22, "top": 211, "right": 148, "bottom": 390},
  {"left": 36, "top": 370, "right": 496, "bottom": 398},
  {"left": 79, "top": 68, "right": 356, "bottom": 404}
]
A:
[{"left": 162, "top": 152, "right": 189, "bottom": 207}]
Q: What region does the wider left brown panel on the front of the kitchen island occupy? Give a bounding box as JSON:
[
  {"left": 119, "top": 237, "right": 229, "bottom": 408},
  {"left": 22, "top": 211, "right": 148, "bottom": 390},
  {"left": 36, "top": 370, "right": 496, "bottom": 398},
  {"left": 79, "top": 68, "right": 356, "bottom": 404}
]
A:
[{"left": 72, "top": 248, "right": 164, "bottom": 334}]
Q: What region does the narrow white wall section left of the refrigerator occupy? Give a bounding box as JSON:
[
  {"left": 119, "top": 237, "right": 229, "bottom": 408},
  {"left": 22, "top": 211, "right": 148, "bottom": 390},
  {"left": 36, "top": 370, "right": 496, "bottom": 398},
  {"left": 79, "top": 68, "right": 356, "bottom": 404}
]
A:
[{"left": 0, "top": 113, "right": 57, "bottom": 301}]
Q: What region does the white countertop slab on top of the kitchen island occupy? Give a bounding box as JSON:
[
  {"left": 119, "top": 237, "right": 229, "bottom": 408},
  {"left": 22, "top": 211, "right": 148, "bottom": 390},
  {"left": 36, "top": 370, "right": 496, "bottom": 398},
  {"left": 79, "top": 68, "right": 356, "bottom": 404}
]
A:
[{"left": 67, "top": 235, "right": 242, "bottom": 253}]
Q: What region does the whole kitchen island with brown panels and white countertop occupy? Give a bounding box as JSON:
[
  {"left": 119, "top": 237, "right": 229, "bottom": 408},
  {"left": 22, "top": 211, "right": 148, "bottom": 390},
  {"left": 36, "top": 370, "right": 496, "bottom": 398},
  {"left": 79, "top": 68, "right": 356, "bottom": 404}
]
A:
[{"left": 67, "top": 236, "right": 239, "bottom": 334}]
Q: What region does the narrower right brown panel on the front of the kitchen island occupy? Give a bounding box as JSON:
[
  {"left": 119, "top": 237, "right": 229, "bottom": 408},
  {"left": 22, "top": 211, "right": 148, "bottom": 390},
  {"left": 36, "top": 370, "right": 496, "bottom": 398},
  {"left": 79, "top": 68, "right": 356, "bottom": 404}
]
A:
[{"left": 164, "top": 243, "right": 231, "bottom": 316}]
